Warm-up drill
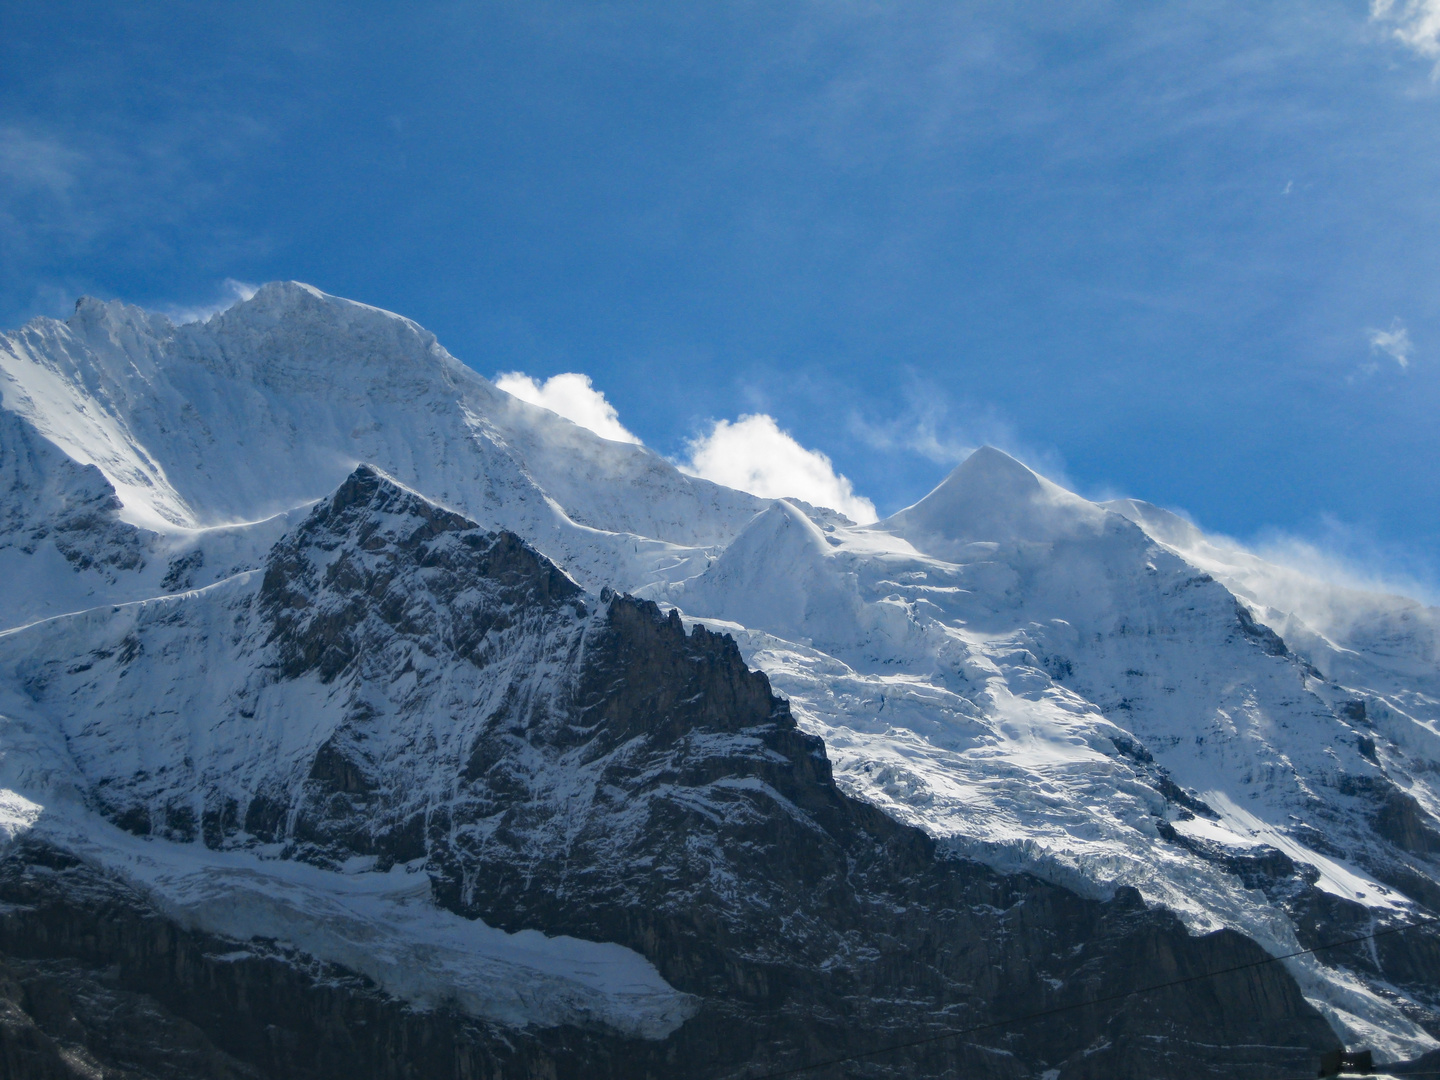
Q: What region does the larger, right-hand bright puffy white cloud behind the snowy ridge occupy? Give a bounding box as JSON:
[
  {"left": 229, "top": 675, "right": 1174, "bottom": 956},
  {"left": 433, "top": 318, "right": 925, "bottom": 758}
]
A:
[{"left": 681, "top": 413, "right": 877, "bottom": 523}]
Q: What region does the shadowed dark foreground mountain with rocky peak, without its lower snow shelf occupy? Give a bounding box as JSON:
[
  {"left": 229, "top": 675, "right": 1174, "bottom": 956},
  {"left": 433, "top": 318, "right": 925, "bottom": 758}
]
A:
[{"left": 0, "top": 467, "right": 1333, "bottom": 1077}]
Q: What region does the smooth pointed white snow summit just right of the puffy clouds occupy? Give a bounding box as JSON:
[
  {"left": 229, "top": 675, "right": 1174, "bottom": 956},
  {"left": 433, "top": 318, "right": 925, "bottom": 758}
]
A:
[{"left": 880, "top": 446, "right": 1106, "bottom": 550}]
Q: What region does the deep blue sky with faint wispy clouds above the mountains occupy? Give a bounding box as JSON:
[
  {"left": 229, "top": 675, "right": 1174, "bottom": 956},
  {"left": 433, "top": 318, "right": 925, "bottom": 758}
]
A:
[{"left": 0, "top": 0, "right": 1440, "bottom": 593}]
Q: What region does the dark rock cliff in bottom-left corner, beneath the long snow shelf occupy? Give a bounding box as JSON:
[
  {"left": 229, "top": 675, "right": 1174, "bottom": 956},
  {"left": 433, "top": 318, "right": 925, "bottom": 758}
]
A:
[{"left": 0, "top": 845, "right": 624, "bottom": 1080}]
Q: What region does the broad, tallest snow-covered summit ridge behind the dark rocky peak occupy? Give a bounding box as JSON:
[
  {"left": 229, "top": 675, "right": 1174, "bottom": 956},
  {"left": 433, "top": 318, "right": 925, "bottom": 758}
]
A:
[{"left": 0, "top": 284, "right": 762, "bottom": 621}]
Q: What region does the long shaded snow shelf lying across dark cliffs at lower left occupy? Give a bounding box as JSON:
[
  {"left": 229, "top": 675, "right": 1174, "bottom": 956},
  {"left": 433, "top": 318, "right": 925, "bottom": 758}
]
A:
[{"left": 42, "top": 817, "right": 698, "bottom": 1038}]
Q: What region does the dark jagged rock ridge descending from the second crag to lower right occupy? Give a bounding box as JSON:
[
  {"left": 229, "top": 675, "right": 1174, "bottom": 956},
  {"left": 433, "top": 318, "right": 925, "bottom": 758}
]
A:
[{"left": 431, "top": 598, "right": 1332, "bottom": 1076}]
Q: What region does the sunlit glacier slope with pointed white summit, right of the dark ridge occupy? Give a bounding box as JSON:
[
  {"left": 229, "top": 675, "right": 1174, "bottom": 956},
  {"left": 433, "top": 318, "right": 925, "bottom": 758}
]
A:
[{"left": 667, "top": 449, "right": 1440, "bottom": 1056}]
